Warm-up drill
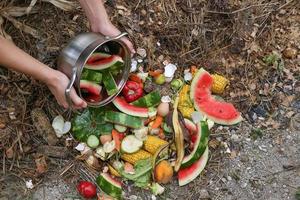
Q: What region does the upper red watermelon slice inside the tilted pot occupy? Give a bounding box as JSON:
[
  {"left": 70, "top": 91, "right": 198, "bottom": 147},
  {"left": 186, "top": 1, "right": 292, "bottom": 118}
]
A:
[{"left": 85, "top": 53, "right": 124, "bottom": 70}]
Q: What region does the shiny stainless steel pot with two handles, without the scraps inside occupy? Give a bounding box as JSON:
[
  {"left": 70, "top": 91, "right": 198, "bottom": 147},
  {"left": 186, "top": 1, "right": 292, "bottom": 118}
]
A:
[{"left": 58, "top": 33, "right": 131, "bottom": 108}]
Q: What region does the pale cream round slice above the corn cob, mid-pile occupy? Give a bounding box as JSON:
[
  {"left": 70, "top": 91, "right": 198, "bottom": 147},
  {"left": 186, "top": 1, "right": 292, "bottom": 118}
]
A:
[{"left": 121, "top": 135, "right": 143, "bottom": 153}]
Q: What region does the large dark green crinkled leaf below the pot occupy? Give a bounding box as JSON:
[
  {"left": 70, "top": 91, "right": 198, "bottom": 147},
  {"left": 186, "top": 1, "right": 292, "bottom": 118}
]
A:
[{"left": 72, "top": 108, "right": 113, "bottom": 142}]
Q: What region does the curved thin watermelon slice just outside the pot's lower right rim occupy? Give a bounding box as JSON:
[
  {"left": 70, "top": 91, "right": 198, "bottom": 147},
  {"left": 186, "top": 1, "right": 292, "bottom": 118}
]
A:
[{"left": 113, "top": 97, "right": 155, "bottom": 117}]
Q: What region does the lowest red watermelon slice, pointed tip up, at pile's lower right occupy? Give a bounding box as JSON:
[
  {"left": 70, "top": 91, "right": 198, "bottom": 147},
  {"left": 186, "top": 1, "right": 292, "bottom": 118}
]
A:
[{"left": 178, "top": 147, "right": 208, "bottom": 186}]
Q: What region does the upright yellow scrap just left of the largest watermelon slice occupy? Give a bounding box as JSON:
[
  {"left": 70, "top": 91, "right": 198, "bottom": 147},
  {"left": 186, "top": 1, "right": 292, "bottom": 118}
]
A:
[{"left": 178, "top": 85, "right": 195, "bottom": 118}]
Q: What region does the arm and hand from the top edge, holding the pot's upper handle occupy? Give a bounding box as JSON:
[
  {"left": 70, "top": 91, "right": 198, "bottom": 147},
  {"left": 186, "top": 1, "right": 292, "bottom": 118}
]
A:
[{"left": 79, "top": 0, "right": 135, "bottom": 53}]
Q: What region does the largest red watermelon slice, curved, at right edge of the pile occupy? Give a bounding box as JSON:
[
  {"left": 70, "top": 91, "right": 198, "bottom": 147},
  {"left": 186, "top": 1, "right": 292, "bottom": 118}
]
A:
[{"left": 190, "top": 68, "right": 243, "bottom": 125}]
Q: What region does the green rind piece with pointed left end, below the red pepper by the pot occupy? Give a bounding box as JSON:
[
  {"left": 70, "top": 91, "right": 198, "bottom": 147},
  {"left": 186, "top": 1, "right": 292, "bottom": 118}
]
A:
[{"left": 131, "top": 91, "right": 161, "bottom": 108}]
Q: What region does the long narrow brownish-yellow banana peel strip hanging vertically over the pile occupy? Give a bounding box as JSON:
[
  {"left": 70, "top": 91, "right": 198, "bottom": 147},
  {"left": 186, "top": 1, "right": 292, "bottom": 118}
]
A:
[{"left": 172, "top": 97, "right": 184, "bottom": 172}]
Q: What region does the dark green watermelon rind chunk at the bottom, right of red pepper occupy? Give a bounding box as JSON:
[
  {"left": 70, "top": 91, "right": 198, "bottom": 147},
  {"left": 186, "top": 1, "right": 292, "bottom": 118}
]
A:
[{"left": 96, "top": 173, "right": 122, "bottom": 199}]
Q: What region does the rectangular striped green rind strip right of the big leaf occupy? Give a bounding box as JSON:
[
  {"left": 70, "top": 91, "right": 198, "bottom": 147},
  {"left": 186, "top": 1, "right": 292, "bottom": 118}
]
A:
[{"left": 104, "top": 111, "right": 143, "bottom": 129}]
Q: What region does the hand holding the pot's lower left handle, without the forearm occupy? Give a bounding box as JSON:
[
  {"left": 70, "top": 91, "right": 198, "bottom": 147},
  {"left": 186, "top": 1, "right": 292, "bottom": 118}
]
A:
[{"left": 46, "top": 70, "right": 87, "bottom": 109}]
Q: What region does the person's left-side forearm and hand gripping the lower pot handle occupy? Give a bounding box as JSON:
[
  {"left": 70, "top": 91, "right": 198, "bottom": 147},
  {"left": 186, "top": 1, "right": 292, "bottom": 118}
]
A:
[{"left": 0, "top": 36, "right": 86, "bottom": 108}]
